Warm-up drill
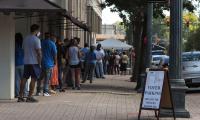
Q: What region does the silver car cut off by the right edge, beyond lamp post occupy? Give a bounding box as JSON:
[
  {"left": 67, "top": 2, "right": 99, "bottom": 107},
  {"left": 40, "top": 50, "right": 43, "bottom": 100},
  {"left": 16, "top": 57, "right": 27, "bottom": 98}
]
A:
[{"left": 182, "top": 51, "right": 200, "bottom": 87}]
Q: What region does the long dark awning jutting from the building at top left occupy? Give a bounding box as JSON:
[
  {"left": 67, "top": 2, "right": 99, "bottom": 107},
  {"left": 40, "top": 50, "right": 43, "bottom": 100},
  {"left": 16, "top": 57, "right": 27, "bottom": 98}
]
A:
[{"left": 0, "top": 0, "right": 89, "bottom": 31}]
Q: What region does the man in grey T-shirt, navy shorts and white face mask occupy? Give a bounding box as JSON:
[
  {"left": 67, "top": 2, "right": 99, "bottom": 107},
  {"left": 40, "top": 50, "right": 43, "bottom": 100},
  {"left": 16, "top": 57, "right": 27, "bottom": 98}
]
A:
[{"left": 18, "top": 24, "right": 42, "bottom": 102}]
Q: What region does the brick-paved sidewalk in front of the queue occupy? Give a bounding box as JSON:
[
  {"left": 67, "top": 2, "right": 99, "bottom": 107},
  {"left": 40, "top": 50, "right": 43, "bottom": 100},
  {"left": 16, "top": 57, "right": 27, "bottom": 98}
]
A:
[{"left": 0, "top": 76, "right": 200, "bottom": 120}]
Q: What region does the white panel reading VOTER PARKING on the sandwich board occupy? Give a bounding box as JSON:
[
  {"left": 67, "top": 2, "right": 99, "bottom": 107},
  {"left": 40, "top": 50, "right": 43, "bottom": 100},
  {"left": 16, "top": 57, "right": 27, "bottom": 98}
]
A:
[{"left": 142, "top": 71, "right": 164, "bottom": 109}]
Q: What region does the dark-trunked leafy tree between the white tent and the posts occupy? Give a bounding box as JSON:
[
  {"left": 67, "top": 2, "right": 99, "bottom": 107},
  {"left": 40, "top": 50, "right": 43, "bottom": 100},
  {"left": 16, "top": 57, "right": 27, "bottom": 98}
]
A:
[{"left": 105, "top": 0, "right": 195, "bottom": 89}]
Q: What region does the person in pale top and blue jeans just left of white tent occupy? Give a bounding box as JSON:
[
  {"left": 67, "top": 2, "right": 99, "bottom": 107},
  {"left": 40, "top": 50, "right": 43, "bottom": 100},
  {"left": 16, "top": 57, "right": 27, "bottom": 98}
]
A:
[{"left": 95, "top": 44, "right": 105, "bottom": 79}]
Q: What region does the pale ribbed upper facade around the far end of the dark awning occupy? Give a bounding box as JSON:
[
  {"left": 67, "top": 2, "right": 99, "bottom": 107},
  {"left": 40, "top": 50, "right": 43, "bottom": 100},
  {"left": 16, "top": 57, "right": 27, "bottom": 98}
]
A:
[{"left": 48, "top": 0, "right": 102, "bottom": 46}]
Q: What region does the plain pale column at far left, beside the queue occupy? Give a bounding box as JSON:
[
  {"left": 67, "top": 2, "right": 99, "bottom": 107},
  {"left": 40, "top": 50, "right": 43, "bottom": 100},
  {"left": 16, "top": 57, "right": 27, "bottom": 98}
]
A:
[{"left": 0, "top": 14, "right": 15, "bottom": 100}]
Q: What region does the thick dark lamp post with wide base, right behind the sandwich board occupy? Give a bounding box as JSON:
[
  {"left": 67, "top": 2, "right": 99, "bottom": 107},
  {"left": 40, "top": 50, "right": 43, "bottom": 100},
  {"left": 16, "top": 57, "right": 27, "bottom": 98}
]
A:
[{"left": 161, "top": 0, "right": 190, "bottom": 118}]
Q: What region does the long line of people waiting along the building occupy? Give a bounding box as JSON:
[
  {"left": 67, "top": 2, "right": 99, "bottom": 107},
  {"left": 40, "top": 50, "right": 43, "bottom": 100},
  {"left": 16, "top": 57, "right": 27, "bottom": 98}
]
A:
[{"left": 15, "top": 24, "right": 131, "bottom": 102}]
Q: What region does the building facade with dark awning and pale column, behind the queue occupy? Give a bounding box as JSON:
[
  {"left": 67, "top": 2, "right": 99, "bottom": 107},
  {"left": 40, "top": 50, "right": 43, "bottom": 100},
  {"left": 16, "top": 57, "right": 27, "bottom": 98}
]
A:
[{"left": 0, "top": 0, "right": 101, "bottom": 99}]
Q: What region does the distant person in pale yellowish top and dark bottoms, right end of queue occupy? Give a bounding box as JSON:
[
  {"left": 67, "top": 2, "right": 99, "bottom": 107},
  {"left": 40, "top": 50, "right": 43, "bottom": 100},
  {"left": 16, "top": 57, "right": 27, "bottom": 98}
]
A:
[{"left": 120, "top": 52, "right": 129, "bottom": 75}]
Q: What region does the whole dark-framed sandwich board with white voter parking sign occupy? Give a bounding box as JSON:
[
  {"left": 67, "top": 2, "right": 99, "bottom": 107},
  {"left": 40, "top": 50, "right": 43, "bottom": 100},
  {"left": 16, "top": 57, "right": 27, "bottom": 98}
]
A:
[{"left": 138, "top": 69, "right": 175, "bottom": 120}]
